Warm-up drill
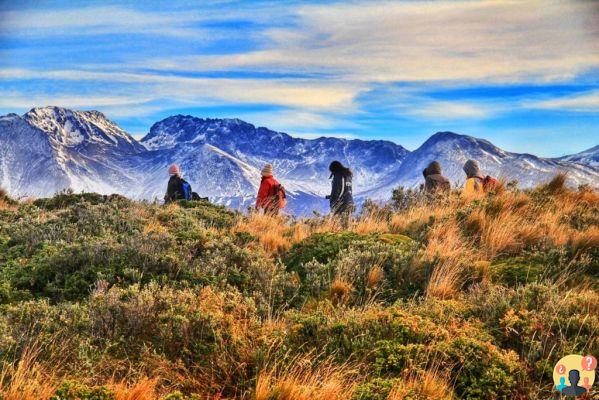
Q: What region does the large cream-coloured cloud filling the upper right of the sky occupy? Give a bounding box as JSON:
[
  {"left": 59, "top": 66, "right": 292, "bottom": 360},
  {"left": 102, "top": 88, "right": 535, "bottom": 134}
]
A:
[{"left": 148, "top": 1, "right": 599, "bottom": 82}]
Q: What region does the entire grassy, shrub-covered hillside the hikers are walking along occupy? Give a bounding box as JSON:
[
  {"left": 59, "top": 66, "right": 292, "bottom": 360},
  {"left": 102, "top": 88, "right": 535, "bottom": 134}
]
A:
[{"left": 0, "top": 177, "right": 599, "bottom": 400}]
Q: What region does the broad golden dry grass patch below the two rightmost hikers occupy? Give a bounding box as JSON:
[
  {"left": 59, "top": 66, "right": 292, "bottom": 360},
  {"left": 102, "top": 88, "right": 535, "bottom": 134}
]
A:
[{"left": 418, "top": 178, "right": 599, "bottom": 298}]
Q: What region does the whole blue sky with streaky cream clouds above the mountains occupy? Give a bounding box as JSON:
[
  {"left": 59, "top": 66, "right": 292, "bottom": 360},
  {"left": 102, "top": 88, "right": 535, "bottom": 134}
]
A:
[{"left": 0, "top": 0, "right": 599, "bottom": 156}]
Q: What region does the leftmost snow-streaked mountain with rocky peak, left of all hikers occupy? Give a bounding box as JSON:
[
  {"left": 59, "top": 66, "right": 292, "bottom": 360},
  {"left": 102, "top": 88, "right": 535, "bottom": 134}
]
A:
[{"left": 0, "top": 107, "right": 146, "bottom": 196}]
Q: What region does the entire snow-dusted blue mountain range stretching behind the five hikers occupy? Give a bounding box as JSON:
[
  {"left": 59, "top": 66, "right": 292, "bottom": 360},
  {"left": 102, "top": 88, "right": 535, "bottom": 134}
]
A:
[{"left": 0, "top": 107, "right": 599, "bottom": 214}]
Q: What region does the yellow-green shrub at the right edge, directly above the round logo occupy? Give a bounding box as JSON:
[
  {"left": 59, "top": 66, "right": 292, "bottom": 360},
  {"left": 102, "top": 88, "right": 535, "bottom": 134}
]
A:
[{"left": 468, "top": 284, "right": 599, "bottom": 381}]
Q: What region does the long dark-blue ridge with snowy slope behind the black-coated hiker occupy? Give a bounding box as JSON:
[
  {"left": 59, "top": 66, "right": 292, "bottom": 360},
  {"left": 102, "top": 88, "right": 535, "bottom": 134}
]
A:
[{"left": 142, "top": 115, "right": 408, "bottom": 196}]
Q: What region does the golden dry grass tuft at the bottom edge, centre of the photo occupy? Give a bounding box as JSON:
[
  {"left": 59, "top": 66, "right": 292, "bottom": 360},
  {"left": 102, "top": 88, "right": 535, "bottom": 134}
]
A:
[{"left": 254, "top": 361, "right": 357, "bottom": 400}]
